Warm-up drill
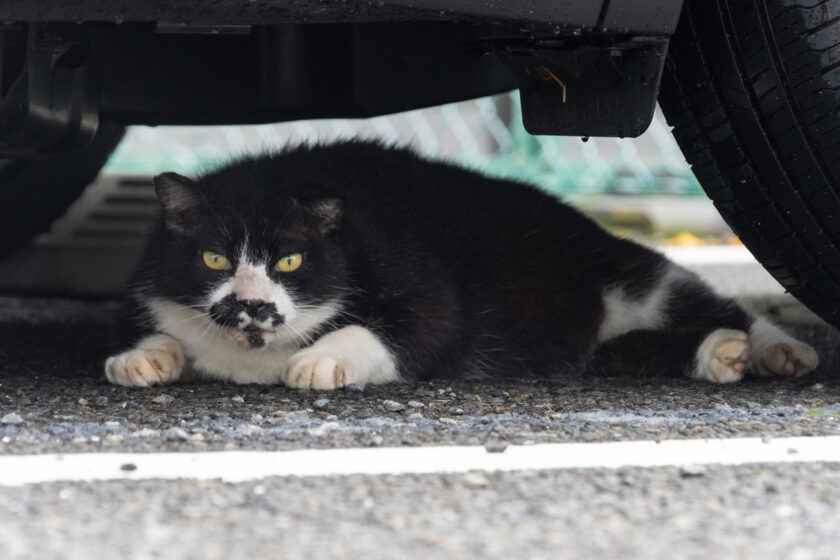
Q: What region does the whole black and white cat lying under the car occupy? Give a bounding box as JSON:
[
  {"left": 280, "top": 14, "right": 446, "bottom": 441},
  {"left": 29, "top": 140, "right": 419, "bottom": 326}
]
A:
[{"left": 105, "top": 142, "right": 817, "bottom": 389}]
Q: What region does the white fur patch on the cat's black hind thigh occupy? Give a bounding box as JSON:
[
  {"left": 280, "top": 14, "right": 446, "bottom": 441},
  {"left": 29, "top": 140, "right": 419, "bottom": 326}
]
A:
[{"left": 598, "top": 263, "right": 694, "bottom": 343}]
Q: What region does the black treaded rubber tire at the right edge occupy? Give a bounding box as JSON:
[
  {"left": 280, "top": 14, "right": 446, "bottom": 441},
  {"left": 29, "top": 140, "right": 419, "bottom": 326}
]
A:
[{"left": 659, "top": 0, "right": 840, "bottom": 327}]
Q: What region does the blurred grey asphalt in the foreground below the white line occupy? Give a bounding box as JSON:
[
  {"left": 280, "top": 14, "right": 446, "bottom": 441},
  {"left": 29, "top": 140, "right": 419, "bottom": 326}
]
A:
[{"left": 0, "top": 463, "right": 840, "bottom": 560}]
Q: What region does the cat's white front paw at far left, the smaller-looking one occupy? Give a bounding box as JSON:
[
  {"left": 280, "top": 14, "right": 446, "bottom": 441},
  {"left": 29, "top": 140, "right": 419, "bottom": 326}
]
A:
[{"left": 105, "top": 335, "right": 186, "bottom": 387}]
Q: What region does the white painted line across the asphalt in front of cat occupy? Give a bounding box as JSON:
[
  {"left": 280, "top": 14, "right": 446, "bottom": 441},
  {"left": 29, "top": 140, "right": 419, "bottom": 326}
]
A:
[{"left": 0, "top": 436, "right": 840, "bottom": 486}]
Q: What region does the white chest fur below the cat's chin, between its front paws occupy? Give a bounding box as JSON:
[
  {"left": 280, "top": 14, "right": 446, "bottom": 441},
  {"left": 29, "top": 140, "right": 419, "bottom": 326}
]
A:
[{"left": 149, "top": 300, "right": 300, "bottom": 384}]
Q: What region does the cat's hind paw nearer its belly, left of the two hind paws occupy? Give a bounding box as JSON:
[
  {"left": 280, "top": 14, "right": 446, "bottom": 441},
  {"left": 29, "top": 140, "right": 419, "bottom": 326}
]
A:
[{"left": 695, "top": 329, "right": 751, "bottom": 383}]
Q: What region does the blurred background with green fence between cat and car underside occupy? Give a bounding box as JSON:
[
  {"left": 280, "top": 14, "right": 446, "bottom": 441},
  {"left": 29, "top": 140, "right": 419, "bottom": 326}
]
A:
[{"left": 0, "top": 91, "right": 737, "bottom": 296}]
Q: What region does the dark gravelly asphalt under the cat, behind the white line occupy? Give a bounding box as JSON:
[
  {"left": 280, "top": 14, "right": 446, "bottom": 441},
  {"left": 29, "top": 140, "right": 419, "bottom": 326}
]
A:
[{"left": 0, "top": 298, "right": 840, "bottom": 453}]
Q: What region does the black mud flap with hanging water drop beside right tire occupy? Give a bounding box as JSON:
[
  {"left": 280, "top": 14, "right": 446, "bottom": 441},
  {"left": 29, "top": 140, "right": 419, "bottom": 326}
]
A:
[{"left": 498, "top": 37, "right": 668, "bottom": 137}]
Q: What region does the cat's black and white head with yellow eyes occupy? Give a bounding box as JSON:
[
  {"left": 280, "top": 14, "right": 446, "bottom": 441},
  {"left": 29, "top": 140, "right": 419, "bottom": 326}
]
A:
[{"left": 146, "top": 168, "right": 347, "bottom": 349}]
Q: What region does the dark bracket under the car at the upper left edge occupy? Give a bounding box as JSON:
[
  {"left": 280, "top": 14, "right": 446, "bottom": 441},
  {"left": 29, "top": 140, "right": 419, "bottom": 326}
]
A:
[{"left": 0, "top": 24, "right": 98, "bottom": 158}]
